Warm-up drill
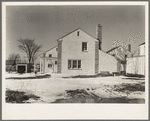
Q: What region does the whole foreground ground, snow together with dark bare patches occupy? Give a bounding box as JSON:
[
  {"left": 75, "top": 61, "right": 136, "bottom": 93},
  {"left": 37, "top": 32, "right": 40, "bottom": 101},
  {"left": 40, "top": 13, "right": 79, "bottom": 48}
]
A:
[{"left": 5, "top": 73, "right": 145, "bottom": 103}]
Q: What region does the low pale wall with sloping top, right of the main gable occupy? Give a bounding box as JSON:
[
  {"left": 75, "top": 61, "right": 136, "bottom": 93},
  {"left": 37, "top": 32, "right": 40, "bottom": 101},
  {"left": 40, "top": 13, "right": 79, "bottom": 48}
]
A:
[{"left": 99, "top": 50, "right": 118, "bottom": 73}]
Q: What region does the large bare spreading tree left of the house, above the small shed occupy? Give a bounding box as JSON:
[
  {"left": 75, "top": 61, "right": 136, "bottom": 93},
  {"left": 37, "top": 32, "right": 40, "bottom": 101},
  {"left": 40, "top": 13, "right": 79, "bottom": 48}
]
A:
[{"left": 18, "top": 38, "right": 42, "bottom": 64}]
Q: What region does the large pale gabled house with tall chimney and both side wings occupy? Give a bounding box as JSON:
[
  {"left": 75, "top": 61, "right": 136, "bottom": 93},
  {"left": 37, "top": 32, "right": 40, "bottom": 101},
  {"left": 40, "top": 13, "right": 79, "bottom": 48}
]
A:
[{"left": 40, "top": 25, "right": 118, "bottom": 75}]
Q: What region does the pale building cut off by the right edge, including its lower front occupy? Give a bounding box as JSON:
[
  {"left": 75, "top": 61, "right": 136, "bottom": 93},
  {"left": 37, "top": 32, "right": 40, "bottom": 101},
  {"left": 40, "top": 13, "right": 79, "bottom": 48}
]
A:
[{"left": 126, "top": 42, "right": 145, "bottom": 75}]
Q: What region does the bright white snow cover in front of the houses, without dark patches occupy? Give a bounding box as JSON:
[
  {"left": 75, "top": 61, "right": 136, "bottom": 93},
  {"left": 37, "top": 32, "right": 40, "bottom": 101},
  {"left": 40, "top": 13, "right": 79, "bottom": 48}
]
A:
[{"left": 5, "top": 73, "right": 145, "bottom": 103}]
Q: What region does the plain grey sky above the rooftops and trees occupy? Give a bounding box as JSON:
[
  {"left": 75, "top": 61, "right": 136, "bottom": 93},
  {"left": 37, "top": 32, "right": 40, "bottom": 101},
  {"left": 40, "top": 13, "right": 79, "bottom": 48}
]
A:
[{"left": 6, "top": 5, "right": 145, "bottom": 58}]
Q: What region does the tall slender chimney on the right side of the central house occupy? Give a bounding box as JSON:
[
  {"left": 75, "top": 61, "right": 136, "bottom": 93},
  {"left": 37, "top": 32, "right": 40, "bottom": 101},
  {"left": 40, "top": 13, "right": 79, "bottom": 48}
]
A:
[{"left": 97, "top": 24, "right": 102, "bottom": 50}]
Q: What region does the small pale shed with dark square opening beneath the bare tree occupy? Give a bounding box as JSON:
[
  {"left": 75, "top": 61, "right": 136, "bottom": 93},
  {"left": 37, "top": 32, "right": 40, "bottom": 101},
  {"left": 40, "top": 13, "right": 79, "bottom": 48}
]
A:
[{"left": 16, "top": 64, "right": 31, "bottom": 73}]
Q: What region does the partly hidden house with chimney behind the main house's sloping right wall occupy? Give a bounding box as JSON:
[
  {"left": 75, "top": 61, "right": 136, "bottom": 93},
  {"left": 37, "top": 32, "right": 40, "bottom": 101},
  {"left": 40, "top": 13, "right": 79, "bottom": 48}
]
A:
[{"left": 106, "top": 44, "right": 132, "bottom": 74}]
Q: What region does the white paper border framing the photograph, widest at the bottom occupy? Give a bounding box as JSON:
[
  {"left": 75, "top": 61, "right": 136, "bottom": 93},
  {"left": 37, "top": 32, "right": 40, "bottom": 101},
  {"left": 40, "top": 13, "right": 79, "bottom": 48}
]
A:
[{"left": 2, "top": 1, "right": 149, "bottom": 120}]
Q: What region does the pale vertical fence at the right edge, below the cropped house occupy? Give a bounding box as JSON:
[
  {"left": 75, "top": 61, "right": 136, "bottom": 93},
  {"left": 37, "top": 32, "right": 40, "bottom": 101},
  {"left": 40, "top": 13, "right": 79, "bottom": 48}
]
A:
[{"left": 126, "top": 56, "right": 145, "bottom": 75}]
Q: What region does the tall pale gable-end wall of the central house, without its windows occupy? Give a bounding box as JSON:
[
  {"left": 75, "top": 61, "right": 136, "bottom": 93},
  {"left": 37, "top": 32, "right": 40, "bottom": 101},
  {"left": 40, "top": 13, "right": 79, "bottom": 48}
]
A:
[{"left": 61, "top": 30, "right": 97, "bottom": 75}]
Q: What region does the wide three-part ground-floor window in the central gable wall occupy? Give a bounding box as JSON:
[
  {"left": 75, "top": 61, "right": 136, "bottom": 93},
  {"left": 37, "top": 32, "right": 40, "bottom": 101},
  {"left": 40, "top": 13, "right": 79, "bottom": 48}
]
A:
[{"left": 68, "top": 60, "right": 81, "bottom": 69}]
